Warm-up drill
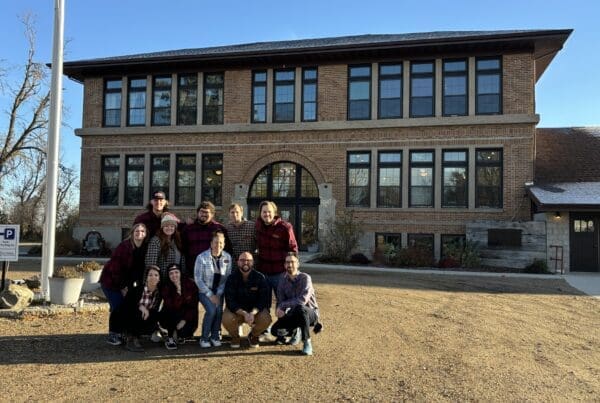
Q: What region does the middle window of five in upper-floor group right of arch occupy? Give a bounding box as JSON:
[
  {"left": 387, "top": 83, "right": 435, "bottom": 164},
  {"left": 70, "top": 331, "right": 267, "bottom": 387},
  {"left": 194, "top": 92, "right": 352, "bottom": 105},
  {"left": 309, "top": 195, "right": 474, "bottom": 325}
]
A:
[{"left": 410, "top": 62, "right": 435, "bottom": 118}]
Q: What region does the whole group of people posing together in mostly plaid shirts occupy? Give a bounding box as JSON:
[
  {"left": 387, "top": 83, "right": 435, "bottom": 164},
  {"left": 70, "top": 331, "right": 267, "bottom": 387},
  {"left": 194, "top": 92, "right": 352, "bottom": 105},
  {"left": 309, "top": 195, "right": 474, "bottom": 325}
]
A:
[{"left": 100, "top": 191, "right": 322, "bottom": 355}]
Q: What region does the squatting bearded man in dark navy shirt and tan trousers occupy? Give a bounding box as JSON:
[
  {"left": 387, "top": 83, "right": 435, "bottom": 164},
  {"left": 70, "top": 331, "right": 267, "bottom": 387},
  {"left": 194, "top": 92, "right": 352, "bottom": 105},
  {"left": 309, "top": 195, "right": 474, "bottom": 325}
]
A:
[{"left": 223, "top": 252, "right": 271, "bottom": 348}]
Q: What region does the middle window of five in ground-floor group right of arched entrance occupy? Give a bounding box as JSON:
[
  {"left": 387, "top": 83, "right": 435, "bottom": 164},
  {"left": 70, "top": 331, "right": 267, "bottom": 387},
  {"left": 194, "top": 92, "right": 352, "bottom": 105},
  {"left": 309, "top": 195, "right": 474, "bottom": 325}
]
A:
[{"left": 409, "top": 151, "right": 434, "bottom": 207}]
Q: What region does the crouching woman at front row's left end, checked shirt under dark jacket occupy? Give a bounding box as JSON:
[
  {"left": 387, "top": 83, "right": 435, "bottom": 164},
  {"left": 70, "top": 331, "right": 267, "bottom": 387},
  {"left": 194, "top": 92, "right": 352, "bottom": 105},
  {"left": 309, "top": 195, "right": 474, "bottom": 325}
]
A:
[{"left": 110, "top": 266, "right": 161, "bottom": 352}]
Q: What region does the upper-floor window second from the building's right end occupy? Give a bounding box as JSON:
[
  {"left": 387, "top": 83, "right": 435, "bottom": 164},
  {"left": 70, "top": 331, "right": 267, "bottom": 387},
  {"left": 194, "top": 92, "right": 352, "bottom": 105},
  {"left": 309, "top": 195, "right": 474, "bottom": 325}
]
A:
[{"left": 442, "top": 59, "right": 468, "bottom": 116}]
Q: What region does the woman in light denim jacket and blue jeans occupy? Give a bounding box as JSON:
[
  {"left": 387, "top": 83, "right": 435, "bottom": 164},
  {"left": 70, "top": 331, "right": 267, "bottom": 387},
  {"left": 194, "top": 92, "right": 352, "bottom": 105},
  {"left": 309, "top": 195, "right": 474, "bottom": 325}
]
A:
[{"left": 194, "top": 230, "right": 232, "bottom": 348}]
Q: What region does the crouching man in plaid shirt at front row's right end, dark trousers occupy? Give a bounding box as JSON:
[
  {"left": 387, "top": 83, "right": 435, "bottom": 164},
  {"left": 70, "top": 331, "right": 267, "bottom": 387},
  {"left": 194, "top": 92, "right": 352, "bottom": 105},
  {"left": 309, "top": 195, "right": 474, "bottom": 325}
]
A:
[{"left": 271, "top": 252, "right": 322, "bottom": 355}]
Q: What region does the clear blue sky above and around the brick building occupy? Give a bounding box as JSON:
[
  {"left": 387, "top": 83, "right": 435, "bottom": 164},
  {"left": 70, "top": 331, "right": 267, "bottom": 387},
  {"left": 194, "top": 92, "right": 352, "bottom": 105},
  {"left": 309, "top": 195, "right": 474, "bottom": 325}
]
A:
[{"left": 0, "top": 0, "right": 600, "bottom": 174}]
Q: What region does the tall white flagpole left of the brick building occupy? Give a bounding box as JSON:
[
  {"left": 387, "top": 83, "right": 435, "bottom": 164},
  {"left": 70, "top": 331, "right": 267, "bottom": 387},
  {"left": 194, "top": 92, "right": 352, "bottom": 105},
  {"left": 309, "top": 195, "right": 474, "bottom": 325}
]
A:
[{"left": 42, "top": 0, "right": 65, "bottom": 301}]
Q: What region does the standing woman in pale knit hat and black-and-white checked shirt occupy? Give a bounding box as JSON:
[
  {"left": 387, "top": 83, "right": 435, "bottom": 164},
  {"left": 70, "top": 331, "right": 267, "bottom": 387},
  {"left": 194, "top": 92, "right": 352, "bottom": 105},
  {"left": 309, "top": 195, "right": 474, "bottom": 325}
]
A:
[{"left": 146, "top": 213, "right": 185, "bottom": 282}]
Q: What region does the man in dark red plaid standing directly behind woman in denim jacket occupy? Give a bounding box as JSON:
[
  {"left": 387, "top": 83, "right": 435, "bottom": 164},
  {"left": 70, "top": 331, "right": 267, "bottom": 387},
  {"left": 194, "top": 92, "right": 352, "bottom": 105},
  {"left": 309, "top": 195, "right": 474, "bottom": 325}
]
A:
[{"left": 181, "top": 201, "right": 231, "bottom": 273}]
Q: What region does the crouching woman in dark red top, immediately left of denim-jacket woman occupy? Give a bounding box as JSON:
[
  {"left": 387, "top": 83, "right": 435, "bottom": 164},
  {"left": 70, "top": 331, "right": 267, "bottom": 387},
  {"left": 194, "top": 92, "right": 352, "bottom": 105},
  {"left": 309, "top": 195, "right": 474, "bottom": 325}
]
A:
[{"left": 159, "top": 264, "right": 198, "bottom": 350}]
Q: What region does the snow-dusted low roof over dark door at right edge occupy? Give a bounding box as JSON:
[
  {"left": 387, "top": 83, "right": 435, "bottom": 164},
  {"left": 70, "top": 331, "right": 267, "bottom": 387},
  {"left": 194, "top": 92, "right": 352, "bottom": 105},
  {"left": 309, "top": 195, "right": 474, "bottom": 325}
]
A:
[{"left": 527, "top": 182, "right": 600, "bottom": 211}]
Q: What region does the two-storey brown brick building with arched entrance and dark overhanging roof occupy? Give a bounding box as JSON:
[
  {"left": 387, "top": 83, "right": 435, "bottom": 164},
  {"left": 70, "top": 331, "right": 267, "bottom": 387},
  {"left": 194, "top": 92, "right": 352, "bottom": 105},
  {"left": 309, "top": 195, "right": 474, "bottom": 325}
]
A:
[{"left": 64, "top": 30, "right": 571, "bottom": 258}]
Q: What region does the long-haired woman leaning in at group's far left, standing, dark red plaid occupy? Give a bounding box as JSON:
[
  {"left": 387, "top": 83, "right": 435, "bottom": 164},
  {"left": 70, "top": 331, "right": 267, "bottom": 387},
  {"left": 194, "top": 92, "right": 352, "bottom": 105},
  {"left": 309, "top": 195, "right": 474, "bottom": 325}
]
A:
[{"left": 100, "top": 223, "right": 148, "bottom": 346}]
